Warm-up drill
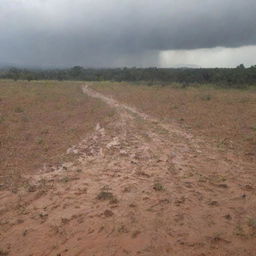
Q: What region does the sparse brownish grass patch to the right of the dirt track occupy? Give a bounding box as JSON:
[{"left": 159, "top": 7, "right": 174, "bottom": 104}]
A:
[{"left": 93, "top": 82, "right": 256, "bottom": 156}]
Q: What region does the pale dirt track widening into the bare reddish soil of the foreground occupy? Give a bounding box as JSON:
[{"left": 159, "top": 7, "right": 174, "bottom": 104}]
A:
[{"left": 0, "top": 86, "right": 256, "bottom": 256}]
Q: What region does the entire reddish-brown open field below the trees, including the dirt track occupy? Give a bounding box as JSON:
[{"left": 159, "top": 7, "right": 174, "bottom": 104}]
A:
[{"left": 0, "top": 82, "right": 256, "bottom": 256}]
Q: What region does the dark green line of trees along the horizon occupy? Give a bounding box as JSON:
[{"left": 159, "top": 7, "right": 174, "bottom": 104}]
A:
[{"left": 0, "top": 64, "right": 256, "bottom": 88}]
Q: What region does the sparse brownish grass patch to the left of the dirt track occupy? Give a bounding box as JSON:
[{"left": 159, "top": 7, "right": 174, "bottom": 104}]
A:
[{"left": 0, "top": 81, "right": 114, "bottom": 187}]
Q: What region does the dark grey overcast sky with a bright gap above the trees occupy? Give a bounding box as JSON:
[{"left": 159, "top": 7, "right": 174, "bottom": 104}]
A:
[{"left": 0, "top": 0, "right": 256, "bottom": 67}]
